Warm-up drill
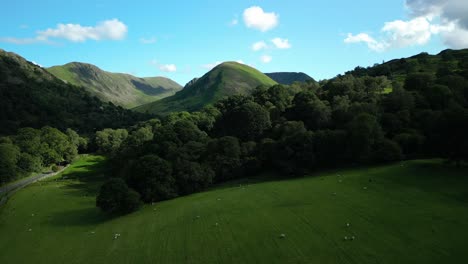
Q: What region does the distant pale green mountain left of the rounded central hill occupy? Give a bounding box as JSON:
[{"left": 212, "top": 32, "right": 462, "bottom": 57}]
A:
[{"left": 47, "top": 62, "right": 182, "bottom": 108}]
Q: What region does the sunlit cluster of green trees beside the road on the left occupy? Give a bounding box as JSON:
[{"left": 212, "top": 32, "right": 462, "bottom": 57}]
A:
[{"left": 0, "top": 127, "right": 87, "bottom": 184}]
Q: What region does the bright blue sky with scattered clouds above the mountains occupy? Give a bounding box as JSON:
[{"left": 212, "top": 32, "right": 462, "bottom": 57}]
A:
[{"left": 0, "top": 0, "right": 468, "bottom": 85}]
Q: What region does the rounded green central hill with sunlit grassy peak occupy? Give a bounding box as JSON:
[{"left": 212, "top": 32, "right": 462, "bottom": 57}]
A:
[{"left": 135, "top": 62, "right": 277, "bottom": 115}]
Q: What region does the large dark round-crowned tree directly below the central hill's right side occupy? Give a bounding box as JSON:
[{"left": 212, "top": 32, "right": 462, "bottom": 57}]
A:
[{"left": 216, "top": 102, "right": 271, "bottom": 141}]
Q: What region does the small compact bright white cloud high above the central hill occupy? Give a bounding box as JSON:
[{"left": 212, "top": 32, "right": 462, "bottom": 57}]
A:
[{"left": 244, "top": 6, "right": 279, "bottom": 32}]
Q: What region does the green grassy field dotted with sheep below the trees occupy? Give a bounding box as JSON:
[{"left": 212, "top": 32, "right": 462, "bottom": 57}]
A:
[{"left": 0, "top": 156, "right": 468, "bottom": 264}]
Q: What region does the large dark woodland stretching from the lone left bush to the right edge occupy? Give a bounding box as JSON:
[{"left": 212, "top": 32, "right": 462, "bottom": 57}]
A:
[{"left": 94, "top": 64, "right": 468, "bottom": 212}]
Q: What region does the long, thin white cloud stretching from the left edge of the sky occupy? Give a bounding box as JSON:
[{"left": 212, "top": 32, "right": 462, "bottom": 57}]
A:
[{"left": 0, "top": 19, "right": 128, "bottom": 44}]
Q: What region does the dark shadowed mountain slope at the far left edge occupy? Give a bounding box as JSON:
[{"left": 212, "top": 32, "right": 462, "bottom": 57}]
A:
[{"left": 0, "top": 49, "right": 145, "bottom": 135}]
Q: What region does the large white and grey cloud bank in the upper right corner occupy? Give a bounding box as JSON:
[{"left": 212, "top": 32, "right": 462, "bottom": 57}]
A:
[{"left": 345, "top": 0, "right": 468, "bottom": 51}]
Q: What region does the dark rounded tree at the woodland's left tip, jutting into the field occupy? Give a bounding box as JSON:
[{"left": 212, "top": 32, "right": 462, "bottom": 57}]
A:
[{"left": 96, "top": 178, "right": 140, "bottom": 214}]
